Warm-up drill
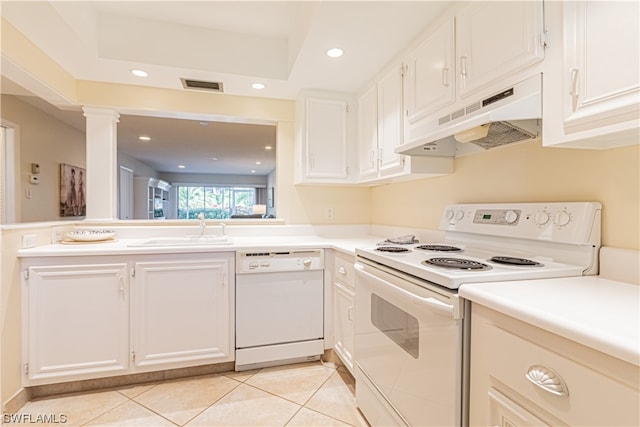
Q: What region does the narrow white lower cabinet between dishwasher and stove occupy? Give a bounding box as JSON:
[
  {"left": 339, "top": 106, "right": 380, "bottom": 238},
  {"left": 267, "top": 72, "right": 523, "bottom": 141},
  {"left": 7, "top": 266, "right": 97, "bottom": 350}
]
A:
[{"left": 333, "top": 253, "right": 356, "bottom": 374}]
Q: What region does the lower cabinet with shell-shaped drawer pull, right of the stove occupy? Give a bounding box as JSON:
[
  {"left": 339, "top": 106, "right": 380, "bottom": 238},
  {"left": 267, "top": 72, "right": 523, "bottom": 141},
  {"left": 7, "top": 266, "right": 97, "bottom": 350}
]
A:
[{"left": 469, "top": 303, "right": 640, "bottom": 427}]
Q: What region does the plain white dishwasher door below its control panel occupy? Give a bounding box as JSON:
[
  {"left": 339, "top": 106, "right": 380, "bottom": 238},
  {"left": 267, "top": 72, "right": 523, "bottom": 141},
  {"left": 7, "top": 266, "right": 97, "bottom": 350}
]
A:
[{"left": 236, "top": 270, "right": 324, "bottom": 372}]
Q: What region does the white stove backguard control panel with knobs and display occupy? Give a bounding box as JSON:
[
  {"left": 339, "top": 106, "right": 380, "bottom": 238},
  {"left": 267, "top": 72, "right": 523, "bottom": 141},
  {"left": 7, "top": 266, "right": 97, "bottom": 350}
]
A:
[{"left": 439, "top": 202, "right": 602, "bottom": 245}]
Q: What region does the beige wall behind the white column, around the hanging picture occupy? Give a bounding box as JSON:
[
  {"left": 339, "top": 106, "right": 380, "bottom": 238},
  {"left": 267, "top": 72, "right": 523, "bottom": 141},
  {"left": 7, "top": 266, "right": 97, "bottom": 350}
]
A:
[{"left": 0, "top": 96, "right": 86, "bottom": 222}]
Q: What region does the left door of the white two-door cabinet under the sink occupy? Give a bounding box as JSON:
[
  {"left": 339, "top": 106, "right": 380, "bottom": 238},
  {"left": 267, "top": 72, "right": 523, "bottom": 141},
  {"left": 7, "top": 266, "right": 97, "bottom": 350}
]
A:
[{"left": 23, "top": 263, "right": 129, "bottom": 385}]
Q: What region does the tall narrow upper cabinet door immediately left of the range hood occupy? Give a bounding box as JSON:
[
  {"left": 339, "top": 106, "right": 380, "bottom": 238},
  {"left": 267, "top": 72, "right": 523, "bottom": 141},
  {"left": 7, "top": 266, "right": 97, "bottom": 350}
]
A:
[{"left": 378, "top": 67, "right": 404, "bottom": 176}]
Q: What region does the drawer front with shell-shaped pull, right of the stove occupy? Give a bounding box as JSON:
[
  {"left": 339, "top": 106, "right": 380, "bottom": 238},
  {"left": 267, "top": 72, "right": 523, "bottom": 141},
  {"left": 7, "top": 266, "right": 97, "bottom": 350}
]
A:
[{"left": 472, "top": 324, "right": 640, "bottom": 426}]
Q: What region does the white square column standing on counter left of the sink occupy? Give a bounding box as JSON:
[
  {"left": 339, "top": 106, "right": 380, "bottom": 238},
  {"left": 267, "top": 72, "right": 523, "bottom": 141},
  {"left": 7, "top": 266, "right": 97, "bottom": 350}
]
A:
[{"left": 82, "top": 107, "right": 120, "bottom": 221}]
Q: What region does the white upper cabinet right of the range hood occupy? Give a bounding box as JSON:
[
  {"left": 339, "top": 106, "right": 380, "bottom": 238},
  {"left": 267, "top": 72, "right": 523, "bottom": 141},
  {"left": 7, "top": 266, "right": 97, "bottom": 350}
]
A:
[{"left": 542, "top": 1, "right": 640, "bottom": 149}]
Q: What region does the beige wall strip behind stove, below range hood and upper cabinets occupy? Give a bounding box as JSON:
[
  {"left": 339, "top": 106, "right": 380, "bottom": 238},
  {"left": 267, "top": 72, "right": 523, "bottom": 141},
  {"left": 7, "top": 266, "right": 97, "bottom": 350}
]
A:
[{"left": 371, "top": 141, "right": 640, "bottom": 249}]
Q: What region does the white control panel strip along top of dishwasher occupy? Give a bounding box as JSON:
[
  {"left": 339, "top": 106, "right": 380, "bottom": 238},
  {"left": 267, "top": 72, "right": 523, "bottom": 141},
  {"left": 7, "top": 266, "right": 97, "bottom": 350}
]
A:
[{"left": 236, "top": 249, "right": 324, "bottom": 274}]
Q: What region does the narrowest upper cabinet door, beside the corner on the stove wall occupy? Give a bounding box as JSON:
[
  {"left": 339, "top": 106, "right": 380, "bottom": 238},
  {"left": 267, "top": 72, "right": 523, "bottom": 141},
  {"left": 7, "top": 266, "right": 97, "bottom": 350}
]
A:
[{"left": 358, "top": 86, "right": 378, "bottom": 179}]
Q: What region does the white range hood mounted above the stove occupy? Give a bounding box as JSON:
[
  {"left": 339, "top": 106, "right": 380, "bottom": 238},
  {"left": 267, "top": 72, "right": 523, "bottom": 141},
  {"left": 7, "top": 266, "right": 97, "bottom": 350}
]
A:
[{"left": 396, "top": 74, "right": 542, "bottom": 157}]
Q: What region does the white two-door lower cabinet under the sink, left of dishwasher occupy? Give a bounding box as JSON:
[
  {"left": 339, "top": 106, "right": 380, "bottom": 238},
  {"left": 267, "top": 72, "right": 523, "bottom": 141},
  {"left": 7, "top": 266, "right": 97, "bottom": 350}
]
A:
[{"left": 22, "top": 252, "right": 235, "bottom": 386}]
